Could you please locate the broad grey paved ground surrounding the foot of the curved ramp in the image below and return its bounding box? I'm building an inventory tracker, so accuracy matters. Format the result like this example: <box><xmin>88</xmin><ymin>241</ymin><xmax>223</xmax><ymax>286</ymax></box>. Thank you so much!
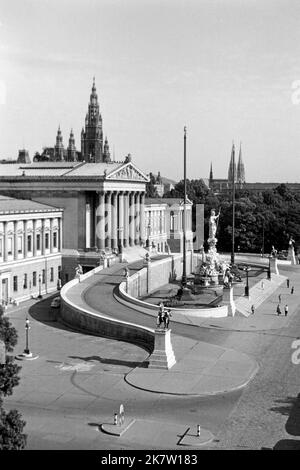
<box><xmin>5</xmin><ymin>258</ymin><xmax>300</xmax><ymax>450</ymax></box>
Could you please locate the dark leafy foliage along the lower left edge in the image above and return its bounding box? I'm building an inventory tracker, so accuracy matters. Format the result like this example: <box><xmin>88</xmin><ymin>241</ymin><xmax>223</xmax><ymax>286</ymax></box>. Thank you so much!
<box><xmin>0</xmin><ymin>306</ymin><xmax>27</xmax><ymax>450</ymax></box>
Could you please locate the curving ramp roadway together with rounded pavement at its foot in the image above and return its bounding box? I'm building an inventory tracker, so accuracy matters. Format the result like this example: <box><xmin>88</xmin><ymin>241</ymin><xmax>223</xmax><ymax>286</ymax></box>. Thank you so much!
<box><xmin>67</xmin><ymin>265</ymin><xmax>258</xmax><ymax>396</ymax></box>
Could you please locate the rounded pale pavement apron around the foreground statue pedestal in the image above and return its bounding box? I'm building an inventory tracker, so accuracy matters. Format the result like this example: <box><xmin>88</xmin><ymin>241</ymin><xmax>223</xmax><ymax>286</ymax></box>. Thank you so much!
<box><xmin>125</xmin><ymin>335</ymin><xmax>258</xmax><ymax>396</ymax></box>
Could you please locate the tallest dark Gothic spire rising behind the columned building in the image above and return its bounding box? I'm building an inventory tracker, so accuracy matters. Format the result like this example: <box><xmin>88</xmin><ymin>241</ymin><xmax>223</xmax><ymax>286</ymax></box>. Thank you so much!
<box><xmin>81</xmin><ymin>78</ymin><xmax>110</xmax><ymax>163</ymax></box>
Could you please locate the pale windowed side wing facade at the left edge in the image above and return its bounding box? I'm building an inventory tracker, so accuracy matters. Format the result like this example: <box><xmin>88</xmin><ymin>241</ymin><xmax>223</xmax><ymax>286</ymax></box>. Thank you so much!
<box><xmin>0</xmin><ymin>196</ymin><xmax>62</xmax><ymax>306</ymax></box>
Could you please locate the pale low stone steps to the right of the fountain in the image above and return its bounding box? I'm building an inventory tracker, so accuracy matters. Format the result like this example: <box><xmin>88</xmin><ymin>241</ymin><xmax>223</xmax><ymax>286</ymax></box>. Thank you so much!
<box><xmin>235</xmin><ymin>274</ymin><xmax>286</xmax><ymax>317</ymax></box>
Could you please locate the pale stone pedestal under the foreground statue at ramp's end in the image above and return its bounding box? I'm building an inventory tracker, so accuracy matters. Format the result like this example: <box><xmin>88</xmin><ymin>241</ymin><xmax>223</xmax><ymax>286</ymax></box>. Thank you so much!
<box><xmin>149</xmin><ymin>328</ymin><xmax>176</xmax><ymax>369</ymax></box>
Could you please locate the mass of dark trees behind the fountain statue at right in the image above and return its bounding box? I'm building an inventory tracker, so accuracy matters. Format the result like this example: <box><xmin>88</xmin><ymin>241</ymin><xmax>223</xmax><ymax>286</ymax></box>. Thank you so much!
<box><xmin>165</xmin><ymin>180</ymin><xmax>300</xmax><ymax>253</ymax></box>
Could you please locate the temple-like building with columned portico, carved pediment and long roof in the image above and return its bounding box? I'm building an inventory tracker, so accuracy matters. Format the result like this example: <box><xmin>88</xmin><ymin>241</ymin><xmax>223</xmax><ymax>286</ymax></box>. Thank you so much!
<box><xmin>0</xmin><ymin>160</ymin><xmax>148</xmax><ymax>280</ymax></box>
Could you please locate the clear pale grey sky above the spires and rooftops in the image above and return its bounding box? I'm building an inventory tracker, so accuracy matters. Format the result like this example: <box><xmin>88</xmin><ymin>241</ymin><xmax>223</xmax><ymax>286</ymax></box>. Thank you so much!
<box><xmin>0</xmin><ymin>0</ymin><xmax>300</xmax><ymax>182</ymax></box>
